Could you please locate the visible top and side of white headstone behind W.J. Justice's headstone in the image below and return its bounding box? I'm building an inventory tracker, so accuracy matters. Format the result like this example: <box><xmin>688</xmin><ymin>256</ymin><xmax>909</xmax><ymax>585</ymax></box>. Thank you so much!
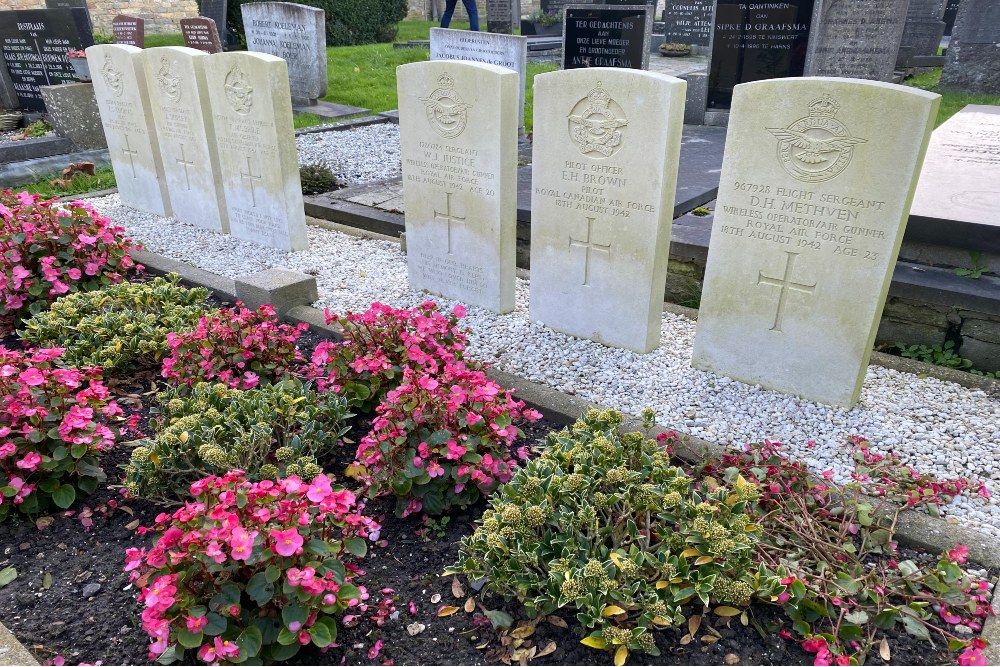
<box><xmin>431</xmin><ymin>28</ymin><xmax>528</xmax><ymax>127</ymax></box>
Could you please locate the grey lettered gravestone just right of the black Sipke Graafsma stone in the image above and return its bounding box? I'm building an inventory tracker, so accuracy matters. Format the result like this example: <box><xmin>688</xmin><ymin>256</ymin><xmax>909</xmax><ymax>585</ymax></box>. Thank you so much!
<box><xmin>805</xmin><ymin>0</ymin><xmax>910</xmax><ymax>81</ymax></box>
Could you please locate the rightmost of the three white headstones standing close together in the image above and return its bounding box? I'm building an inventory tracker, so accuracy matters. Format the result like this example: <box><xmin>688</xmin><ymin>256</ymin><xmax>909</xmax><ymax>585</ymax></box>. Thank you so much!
<box><xmin>204</xmin><ymin>52</ymin><xmax>309</xmax><ymax>250</ymax></box>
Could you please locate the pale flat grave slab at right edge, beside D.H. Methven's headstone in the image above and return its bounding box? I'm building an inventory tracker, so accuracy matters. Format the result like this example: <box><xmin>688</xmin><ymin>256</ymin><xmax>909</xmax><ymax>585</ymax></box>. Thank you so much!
<box><xmin>910</xmin><ymin>104</ymin><xmax>1000</xmax><ymax>252</ymax></box>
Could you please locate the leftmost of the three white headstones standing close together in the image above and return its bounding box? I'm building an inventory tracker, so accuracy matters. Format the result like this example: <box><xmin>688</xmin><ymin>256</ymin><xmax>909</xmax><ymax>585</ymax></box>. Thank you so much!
<box><xmin>87</xmin><ymin>44</ymin><xmax>171</xmax><ymax>215</ymax></box>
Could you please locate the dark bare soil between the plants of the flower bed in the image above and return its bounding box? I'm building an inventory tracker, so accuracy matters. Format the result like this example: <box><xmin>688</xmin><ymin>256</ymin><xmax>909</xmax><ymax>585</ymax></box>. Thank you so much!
<box><xmin>0</xmin><ymin>316</ymin><xmax>988</xmax><ymax>665</ymax></box>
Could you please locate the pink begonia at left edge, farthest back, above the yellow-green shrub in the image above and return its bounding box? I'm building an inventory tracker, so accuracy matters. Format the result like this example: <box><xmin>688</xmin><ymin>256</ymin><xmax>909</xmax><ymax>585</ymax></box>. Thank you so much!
<box><xmin>0</xmin><ymin>190</ymin><xmax>141</xmax><ymax>334</ymax></box>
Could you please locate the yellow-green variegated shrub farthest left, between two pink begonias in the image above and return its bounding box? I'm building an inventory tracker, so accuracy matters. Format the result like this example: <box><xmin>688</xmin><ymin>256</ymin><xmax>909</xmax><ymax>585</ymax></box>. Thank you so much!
<box><xmin>19</xmin><ymin>274</ymin><xmax>210</xmax><ymax>377</ymax></box>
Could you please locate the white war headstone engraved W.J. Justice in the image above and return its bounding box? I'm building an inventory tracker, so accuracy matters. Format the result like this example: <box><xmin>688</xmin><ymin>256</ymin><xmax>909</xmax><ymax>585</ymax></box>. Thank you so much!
<box><xmin>396</xmin><ymin>60</ymin><xmax>518</xmax><ymax>313</ymax></box>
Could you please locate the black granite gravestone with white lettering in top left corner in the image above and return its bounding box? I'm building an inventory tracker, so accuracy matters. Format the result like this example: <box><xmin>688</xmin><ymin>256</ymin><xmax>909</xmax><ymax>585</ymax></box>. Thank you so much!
<box><xmin>0</xmin><ymin>9</ymin><xmax>94</xmax><ymax>111</ymax></box>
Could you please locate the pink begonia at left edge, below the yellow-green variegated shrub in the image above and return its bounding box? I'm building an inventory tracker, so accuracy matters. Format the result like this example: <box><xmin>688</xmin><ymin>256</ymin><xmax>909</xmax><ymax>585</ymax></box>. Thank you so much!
<box><xmin>0</xmin><ymin>346</ymin><xmax>122</xmax><ymax>520</ymax></box>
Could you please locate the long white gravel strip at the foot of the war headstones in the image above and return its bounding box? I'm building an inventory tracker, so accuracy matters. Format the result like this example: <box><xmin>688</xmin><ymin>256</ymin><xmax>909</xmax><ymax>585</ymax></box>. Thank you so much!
<box><xmin>86</xmin><ymin>195</ymin><xmax>1000</xmax><ymax>536</ymax></box>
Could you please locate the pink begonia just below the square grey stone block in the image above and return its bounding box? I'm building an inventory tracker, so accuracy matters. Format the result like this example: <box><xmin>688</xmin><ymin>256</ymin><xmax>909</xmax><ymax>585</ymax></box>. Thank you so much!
<box><xmin>162</xmin><ymin>303</ymin><xmax>309</xmax><ymax>389</ymax></box>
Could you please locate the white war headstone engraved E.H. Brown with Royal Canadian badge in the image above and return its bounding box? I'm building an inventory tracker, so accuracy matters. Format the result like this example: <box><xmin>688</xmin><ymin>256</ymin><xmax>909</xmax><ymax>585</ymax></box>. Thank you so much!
<box><xmin>531</xmin><ymin>67</ymin><xmax>686</xmax><ymax>353</ymax></box>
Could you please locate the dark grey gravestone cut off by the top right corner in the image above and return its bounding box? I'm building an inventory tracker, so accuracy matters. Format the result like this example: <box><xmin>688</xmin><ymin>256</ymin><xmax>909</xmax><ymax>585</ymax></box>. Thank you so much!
<box><xmin>940</xmin><ymin>0</ymin><xmax>1000</xmax><ymax>95</ymax></box>
